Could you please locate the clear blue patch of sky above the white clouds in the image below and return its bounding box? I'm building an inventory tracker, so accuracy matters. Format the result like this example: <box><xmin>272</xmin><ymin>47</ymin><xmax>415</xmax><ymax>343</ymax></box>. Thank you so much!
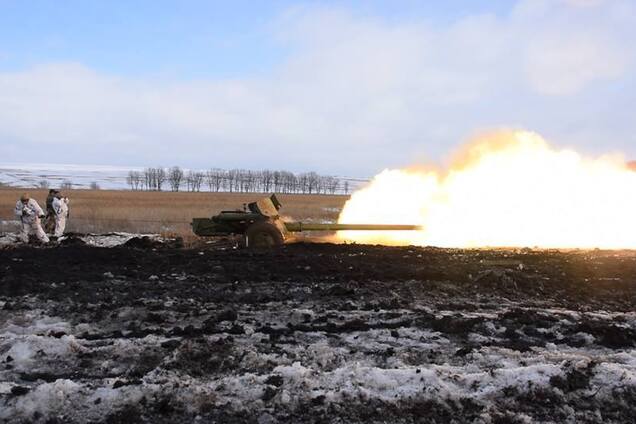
<box><xmin>0</xmin><ymin>0</ymin><xmax>511</xmax><ymax>79</ymax></box>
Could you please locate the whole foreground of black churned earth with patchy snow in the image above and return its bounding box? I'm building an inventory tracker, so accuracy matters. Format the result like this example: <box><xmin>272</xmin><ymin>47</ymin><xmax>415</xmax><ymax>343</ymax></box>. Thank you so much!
<box><xmin>0</xmin><ymin>239</ymin><xmax>636</xmax><ymax>424</ymax></box>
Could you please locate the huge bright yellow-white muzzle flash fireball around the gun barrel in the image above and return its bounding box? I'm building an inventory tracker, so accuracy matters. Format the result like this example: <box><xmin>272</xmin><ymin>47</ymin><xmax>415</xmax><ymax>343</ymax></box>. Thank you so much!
<box><xmin>338</xmin><ymin>131</ymin><xmax>636</xmax><ymax>248</ymax></box>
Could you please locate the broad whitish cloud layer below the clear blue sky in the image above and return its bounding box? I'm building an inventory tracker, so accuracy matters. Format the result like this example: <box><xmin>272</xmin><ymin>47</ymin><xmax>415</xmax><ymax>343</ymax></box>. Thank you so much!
<box><xmin>0</xmin><ymin>0</ymin><xmax>636</xmax><ymax>175</ymax></box>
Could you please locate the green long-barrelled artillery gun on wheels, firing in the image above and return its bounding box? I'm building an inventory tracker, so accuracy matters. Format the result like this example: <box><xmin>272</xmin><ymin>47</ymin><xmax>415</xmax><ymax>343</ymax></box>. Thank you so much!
<box><xmin>191</xmin><ymin>194</ymin><xmax>420</xmax><ymax>247</ymax></box>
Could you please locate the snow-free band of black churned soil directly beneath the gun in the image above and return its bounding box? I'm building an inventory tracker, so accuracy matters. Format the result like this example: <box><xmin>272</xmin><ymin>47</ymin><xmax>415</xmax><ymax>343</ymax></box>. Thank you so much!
<box><xmin>0</xmin><ymin>239</ymin><xmax>636</xmax><ymax>311</ymax></box>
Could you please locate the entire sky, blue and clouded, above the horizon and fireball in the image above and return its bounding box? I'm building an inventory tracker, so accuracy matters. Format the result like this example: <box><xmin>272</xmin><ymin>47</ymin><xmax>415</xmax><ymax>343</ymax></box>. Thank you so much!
<box><xmin>0</xmin><ymin>0</ymin><xmax>636</xmax><ymax>176</ymax></box>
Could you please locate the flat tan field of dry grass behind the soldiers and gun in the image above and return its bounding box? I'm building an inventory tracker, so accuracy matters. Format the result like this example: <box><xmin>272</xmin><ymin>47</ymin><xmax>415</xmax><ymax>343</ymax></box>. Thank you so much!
<box><xmin>0</xmin><ymin>188</ymin><xmax>349</xmax><ymax>235</ymax></box>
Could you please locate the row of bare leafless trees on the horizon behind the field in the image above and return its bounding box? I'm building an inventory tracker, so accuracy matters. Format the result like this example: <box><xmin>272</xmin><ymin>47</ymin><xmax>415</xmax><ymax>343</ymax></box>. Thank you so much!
<box><xmin>126</xmin><ymin>166</ymin><xmax>349</xmax><ymax>194</ymax></box>
